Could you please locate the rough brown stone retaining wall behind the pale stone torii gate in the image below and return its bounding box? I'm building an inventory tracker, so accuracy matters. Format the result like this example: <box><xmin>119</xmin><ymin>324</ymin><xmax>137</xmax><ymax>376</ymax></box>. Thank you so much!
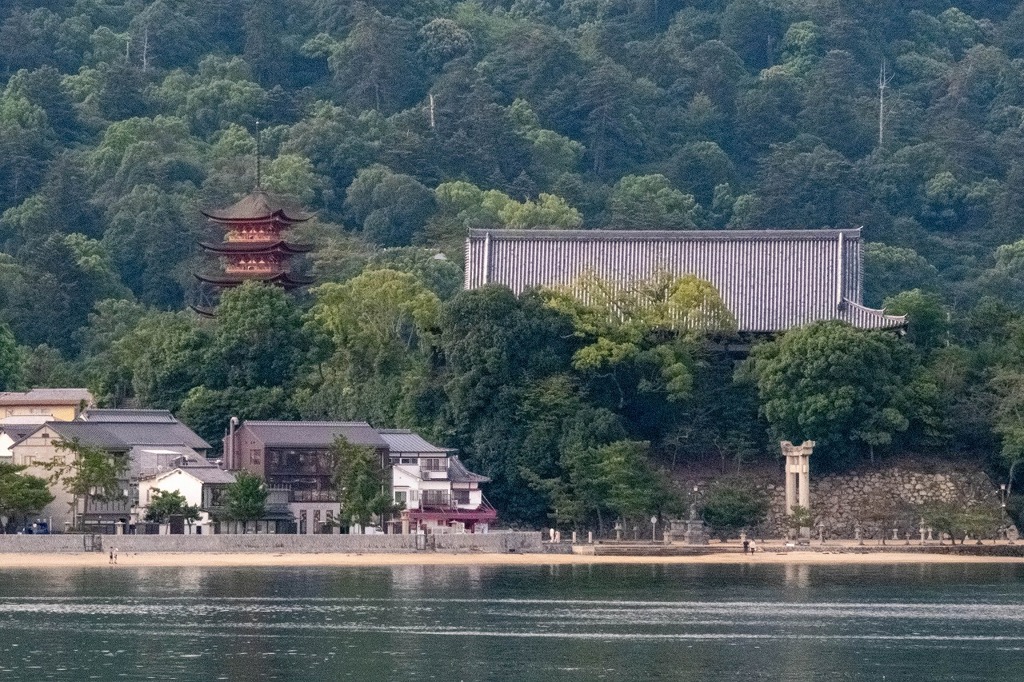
<box><xmin>765</xmin><ymin>467</ymin><xmax>998</xmax><ymax>540</ymax></box>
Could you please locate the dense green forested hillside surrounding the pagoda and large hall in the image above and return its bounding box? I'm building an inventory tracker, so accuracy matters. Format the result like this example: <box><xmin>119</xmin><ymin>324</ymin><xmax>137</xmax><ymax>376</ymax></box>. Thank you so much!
<box><xmin>0</xmin><ymin>0</ymin><xmax>1024</xmax><ymax>522</ymax></box>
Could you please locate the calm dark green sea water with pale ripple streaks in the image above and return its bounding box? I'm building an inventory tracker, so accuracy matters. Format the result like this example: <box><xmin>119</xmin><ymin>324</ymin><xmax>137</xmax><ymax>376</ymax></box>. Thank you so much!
<box><xmin>0</xmin><ymin>557</ymin><xmax>1024</xmax><ymax>682</ymax></box>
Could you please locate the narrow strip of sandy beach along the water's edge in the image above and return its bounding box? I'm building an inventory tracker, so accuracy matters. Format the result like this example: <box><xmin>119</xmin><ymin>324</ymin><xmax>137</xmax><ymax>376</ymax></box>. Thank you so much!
<box><xmin>0</xmin><ymin>549</ymin><xmax>1024</xmax><ymax>570</ymax></box>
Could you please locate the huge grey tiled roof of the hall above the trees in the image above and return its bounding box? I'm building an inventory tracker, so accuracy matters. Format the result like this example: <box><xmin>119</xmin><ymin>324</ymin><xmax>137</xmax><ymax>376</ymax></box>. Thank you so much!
<box><xmin>465</xmin><ymin>228</ymin><xmax>905</xmax><ymax>332</ymax></box>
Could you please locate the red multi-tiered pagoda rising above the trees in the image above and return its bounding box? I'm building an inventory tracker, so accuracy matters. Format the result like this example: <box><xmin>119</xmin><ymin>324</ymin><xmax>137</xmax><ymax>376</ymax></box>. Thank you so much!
<box><xmin>196</xmin><ymin>186</ymin><xmax>312</xmax><ymax>289</ymax></box>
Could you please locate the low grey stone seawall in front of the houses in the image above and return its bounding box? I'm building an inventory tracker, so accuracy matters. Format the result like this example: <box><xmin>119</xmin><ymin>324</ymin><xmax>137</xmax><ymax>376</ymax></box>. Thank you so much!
<box><xmin>0</xmin><ymin>531</ymin><xmax>544</xmax><ymax>554</ymax></box>
